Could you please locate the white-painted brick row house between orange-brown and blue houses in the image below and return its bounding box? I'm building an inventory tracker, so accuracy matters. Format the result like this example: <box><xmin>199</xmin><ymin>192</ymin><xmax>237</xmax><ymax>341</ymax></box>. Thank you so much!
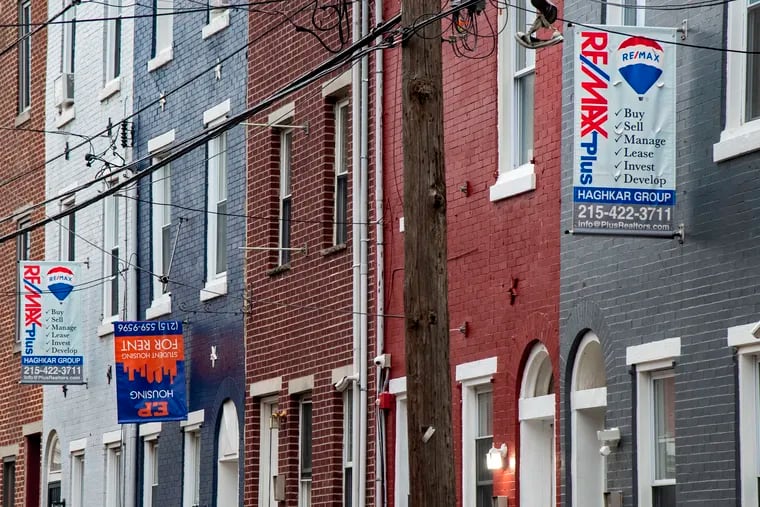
<box><xmin>42</xmin><ymin>2</ymin><xmax>137</xmax><ymax>506</ymax></box>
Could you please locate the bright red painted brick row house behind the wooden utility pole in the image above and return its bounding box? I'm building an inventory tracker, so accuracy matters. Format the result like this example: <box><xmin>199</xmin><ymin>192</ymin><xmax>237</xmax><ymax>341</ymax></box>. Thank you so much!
<box><xmin>383</xmin><ymin>2</ymin><xmax>562</xmax><ymax>507</ymax></box>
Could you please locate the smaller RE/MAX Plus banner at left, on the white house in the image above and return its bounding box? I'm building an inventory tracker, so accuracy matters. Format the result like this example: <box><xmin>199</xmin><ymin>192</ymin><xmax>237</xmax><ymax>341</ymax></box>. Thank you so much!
<box><xmin>19</xmin><ymin>261</ymin><xmax>84</xmax><ymax>384</ymax></box>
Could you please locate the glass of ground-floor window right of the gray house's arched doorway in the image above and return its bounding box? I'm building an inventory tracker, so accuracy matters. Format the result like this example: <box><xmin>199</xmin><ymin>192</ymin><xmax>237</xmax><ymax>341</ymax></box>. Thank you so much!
<box><xmin>652</xmin><ymin>377</ymin><xmax>676</xmax><ymax>480</ymax></box>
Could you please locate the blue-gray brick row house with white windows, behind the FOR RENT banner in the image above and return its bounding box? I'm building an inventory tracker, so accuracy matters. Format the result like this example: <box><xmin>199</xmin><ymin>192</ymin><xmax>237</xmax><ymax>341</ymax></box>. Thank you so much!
<box><xmin>134</xmin><ymin>0</ymin><xmax>248</xmax><ymax>507</ymax></box>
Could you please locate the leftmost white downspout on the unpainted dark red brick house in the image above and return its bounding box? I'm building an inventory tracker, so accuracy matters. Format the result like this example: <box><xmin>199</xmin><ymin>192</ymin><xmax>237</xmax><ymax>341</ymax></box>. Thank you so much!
<box><xmin>351</xmin><ymin>0</ymin><xmax>366</xmax><ymax>505</ymax></box>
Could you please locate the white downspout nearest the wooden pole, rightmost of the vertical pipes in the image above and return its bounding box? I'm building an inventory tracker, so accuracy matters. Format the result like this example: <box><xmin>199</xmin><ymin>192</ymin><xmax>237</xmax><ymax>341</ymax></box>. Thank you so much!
<box><xmin>375</xmin><ymin>0</ymin><xmax>387</xmax><ymax>507</ymax></box>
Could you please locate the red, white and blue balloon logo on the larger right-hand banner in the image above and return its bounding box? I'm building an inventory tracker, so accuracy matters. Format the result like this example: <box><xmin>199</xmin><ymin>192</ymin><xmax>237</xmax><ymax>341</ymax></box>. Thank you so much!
<box><xmin>618</xmin><ymin>37</ymin><xmax>665</xmax><ymax>100</ymax></box>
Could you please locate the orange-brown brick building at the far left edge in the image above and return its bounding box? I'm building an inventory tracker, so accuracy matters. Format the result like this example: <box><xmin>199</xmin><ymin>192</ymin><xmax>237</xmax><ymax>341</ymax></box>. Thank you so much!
<box><xmin>0</xmin><ymin>1</ymin><xmax>47</xmax><ymax>507</ymax></box>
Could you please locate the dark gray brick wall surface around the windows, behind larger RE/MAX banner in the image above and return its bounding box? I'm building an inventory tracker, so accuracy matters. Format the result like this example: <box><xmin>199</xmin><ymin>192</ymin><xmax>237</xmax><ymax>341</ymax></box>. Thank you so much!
<box><xmin>560</xmin><ymin>0</ymin><xmax>760</xmax><ymax>507</ymax></box>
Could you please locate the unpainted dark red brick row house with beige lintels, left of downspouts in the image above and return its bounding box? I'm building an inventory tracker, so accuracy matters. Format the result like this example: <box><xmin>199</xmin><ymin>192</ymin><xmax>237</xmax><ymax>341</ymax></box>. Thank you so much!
<box><xmin>244</xmin><ymin>1</ymin><xmax>380</xmax><ymax>507</ymax></box>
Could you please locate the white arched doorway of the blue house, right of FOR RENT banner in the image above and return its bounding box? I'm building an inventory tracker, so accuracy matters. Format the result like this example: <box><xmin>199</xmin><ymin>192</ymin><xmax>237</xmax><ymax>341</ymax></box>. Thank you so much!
<box><xmin>216</xmin><ymin>400</ymin><xmax>240</xmax><ymax>507</ymax></box>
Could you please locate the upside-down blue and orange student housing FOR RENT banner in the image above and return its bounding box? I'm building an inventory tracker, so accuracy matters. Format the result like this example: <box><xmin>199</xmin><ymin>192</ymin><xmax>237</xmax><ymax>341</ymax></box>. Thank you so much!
<box><xmin>114</xmin><ymin>321</ymin><xmax>187</xmax><ymax>424</ymax></box>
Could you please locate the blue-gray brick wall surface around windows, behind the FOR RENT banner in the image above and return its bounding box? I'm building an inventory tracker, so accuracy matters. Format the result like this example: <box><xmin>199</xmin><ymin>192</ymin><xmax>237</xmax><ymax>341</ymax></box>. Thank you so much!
<box><xmin>134</xmin><ymin>1</ymin><xmax>248</xmax><ymax>507</ymax></box>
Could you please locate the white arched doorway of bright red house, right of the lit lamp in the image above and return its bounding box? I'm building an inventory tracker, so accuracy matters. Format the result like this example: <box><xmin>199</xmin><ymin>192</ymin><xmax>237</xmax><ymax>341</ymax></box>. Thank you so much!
<box><xmin>519</xmin><ymin>343</ymin><xmax>556</xmax><ymax>507</ymax></box>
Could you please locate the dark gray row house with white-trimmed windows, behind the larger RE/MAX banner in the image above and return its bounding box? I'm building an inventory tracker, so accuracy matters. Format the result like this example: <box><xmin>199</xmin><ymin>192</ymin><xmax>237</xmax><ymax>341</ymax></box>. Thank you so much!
<box><xmin>559</xmin><ymin>0</ymin><xmax>760</xmax><ymax>507</ymax></box>
